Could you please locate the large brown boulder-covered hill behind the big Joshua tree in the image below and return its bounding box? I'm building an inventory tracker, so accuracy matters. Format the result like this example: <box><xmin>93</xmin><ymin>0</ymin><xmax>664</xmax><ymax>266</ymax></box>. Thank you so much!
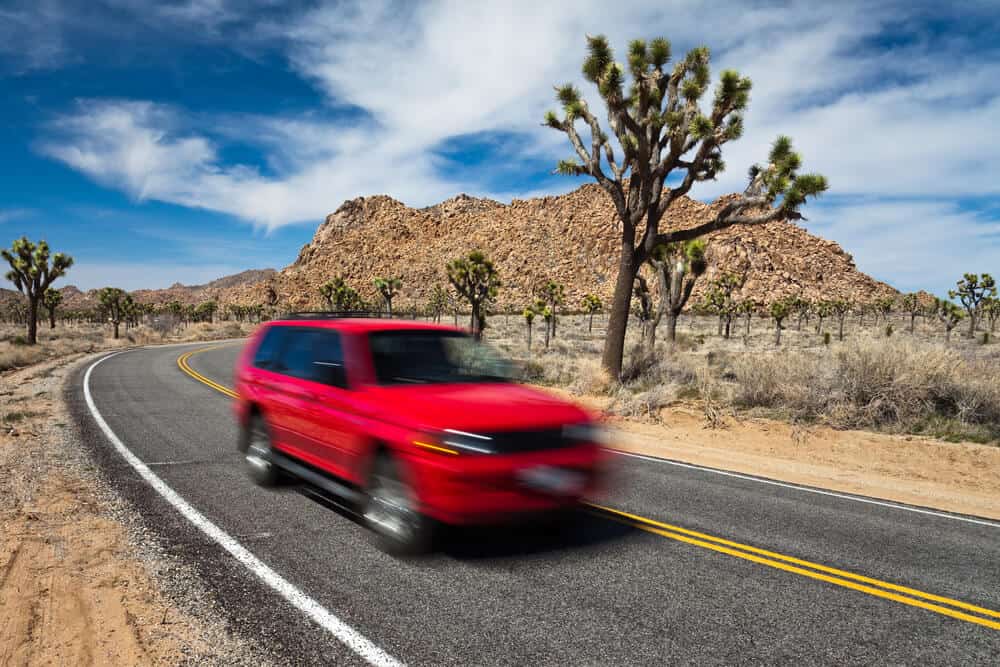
<box><xmin>222</xmin><ymin>184</ymin><xmax>896</xmax><ymax>309</ymax></box>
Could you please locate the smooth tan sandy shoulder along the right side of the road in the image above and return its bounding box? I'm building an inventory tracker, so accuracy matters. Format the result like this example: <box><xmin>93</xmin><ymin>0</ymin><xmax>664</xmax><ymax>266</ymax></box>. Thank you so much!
<box><xmin>560</xmin><ymin>396</ymin><xmax>1000</xmax><ymax>519</ymax></box>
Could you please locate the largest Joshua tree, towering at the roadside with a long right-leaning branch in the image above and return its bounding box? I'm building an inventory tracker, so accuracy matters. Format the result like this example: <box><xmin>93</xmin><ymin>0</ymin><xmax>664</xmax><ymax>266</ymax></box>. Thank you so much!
<box><xmin>545</xmin><ymin>36</ymin><xmax>827</xmax><ymax>378</ymax></box>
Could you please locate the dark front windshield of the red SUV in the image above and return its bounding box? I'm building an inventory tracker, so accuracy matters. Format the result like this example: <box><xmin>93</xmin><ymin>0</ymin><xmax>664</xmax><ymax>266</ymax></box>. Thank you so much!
<box><xmin>369</xmin><ymin>330</ymin><xmax>513</xmax><ymax>384</ymax></box>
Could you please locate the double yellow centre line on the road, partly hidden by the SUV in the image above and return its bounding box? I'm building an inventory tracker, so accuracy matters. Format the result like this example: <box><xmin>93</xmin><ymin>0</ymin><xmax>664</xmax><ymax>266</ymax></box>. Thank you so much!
<box><xmin>177</xmin><ymin>345</ymin><xmax>1000</xmax><ymax>630</ymax></box>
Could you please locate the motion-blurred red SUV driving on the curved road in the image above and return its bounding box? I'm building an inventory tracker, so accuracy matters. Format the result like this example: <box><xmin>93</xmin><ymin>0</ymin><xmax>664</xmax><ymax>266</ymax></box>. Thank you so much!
<box><xmin>235</xmin><ymin>315</ymin><xmax>606</xmax><ymax>552</ymax></box>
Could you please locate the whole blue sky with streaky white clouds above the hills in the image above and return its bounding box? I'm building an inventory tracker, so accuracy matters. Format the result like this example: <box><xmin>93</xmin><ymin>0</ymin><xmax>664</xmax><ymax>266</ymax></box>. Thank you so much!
<box><xmin>0</xmin><ymin>0</ymin><xmax>1000</xmax><ymax>293</ymax></box>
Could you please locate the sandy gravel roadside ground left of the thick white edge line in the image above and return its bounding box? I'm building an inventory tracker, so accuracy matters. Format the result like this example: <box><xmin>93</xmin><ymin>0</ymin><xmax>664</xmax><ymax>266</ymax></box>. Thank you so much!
<box><xmin>0</xmin><ymin>358</ymin><xmax>260</xmax><ymax>665</ymax></box>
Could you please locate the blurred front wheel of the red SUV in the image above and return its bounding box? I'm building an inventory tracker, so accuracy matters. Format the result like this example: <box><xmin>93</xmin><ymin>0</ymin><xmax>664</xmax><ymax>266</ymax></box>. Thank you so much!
<box><xmin>362</xmin><ymin>454</ymin><xmax>433</xmax><ymax>556</ymax></box>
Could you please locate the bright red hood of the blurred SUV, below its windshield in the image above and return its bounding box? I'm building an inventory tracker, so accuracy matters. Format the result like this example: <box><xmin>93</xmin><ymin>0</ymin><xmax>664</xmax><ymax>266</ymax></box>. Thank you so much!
<box><xmin>366</xmin><ymin>383</ymin><xmax>590</xmax><ymax>433</ymax></box>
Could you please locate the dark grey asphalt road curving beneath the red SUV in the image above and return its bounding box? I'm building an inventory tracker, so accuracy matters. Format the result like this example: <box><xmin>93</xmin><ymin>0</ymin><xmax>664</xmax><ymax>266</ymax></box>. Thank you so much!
<box><xmin>69</xmin><ymin>345</ymin><xmax>1000</xmax><ymax>665</ymax></box>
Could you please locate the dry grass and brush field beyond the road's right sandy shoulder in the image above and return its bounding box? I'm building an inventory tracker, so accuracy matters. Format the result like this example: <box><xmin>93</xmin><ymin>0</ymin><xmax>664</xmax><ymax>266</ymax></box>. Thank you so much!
<box><xmin>487</xmin><ymin>316</ymin><xmax>1000</xmax><ymax>442</ymax></box>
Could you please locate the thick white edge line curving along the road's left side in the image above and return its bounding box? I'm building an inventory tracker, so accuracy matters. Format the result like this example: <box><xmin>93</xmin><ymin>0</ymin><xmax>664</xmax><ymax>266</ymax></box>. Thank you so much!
<box><xmin>83</xmin><ymin>352</ymin><xmax>403</xmax><ymax>667</ymax></box>
